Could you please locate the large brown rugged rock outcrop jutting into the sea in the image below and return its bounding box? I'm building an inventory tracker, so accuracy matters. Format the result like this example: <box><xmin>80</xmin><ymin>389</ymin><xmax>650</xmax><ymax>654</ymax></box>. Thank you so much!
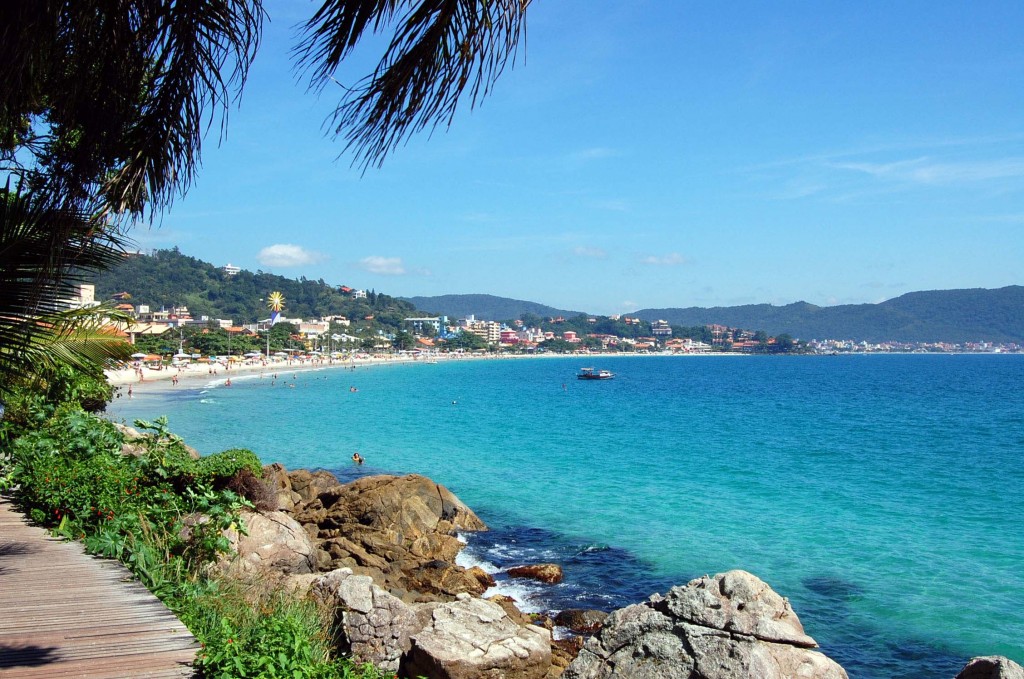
<box><xmin>288</xmin><ymin>468</ymin><xmax>487</xmax><ymax>602</ymax></box>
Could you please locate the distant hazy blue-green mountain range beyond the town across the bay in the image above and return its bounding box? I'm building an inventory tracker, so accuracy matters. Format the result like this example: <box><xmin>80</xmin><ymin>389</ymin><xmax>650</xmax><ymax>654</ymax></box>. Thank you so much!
<box><xmin>407</xmin><ymin>286</ymin><xmax>1024</xmax><ymax>343</ymax></box>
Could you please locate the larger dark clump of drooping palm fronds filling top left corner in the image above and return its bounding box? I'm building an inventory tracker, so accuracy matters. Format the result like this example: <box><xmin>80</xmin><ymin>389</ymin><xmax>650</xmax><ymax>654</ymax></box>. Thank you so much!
<box><xmin>0</xmin><ymin>0</ymin><xmax>263</xmax><ymax>216</ymax></box>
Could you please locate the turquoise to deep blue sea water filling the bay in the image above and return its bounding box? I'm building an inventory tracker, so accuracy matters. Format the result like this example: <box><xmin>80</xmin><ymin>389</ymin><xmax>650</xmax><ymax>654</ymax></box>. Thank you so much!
<box><xmin>112</xmin><ymin>355</ymin><xmax>1024</xmax><ymax>679</ymax></box>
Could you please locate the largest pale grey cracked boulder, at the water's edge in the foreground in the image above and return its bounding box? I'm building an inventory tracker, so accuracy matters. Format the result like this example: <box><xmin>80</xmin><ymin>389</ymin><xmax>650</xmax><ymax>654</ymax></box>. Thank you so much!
<box><xmin>563</xmin><ymin>570</ymin><xmax>847</xmax><ymax>679</ymax></box>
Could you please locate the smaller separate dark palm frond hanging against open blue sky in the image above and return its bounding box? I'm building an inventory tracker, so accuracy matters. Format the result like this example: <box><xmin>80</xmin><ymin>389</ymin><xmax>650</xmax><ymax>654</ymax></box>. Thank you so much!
<box><xmin>297</xmin><ymin>0</ymin><xmax>529</xmax><ymax>168</ymax></box>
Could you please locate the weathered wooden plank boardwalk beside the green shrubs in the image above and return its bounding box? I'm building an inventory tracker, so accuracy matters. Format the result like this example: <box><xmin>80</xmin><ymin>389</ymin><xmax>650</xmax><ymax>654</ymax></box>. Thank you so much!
<box><xmin>0</xmin><ymin>500</ymin><xmax>199</xmax><ymax>679</ymax></box>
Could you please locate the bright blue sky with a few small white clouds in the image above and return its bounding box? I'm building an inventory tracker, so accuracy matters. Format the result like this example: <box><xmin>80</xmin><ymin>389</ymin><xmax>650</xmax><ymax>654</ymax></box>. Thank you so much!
<box><xmin>132</xmin><ymin>0</ymin><xmax>1024</xmax><ymax>313</ymax></box>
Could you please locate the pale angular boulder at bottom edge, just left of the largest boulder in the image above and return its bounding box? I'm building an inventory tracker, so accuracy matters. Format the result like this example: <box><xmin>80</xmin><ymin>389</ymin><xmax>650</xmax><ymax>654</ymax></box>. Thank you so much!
<box><xmin>400</xmin><ymin>594</ymin><xmax>551</xmax><ymax>679</ymax></box>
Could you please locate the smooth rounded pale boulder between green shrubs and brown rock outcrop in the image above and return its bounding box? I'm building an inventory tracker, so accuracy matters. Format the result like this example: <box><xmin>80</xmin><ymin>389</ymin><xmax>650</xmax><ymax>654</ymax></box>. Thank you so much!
<box><xmin>228</xmin><ymin>511</ymin><xmax>316</xmax><ymax>575</ymax></box>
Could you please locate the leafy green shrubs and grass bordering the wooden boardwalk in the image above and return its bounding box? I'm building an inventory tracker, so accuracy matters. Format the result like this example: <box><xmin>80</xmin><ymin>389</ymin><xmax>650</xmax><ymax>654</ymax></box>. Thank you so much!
<box><xmin>0</xmin><ymin>377</ymin><xmax>395</xmax><ymax>679</ymax></box>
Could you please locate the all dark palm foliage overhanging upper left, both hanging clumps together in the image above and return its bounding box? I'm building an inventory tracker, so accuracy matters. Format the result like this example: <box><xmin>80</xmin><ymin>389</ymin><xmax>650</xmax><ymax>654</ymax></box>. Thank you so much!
<box><xmin>6</xmin><ymin>0</ymin><xmax>529</xmax><ymax>393</ymax></box>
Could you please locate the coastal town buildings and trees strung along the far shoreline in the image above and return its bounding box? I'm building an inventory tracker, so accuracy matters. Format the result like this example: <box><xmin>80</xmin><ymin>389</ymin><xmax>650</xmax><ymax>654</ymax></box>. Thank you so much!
<box><xmin>68</xmin><ymin>278</ymin><xmax>1024</xmax><ymax>359</ymax></box>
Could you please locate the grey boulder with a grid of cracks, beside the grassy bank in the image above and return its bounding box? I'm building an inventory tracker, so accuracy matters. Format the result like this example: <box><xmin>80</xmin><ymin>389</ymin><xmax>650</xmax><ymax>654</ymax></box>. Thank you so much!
<box><xmin>309</xmin><ymin>568</ymin><xmax>419</xmax><ymax>672</ymax></box>
